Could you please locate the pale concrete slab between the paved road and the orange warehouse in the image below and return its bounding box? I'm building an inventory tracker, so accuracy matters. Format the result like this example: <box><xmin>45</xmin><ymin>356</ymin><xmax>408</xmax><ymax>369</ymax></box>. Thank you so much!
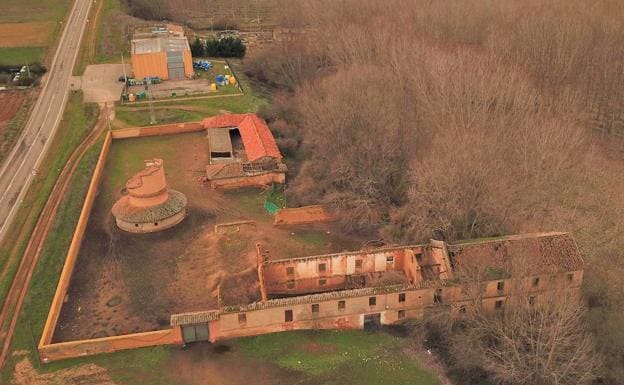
<box><xmin>81</xmin><ymin>64</ymin><xmax>132</xmax><ymax>103</ymax></box>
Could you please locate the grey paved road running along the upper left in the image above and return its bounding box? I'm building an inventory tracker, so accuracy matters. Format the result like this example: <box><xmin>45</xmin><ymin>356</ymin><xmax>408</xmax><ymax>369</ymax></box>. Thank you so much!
<box><xmin>0</xmin><ymin>0</ymin><xmax>92</xmax><ymax>240</ymax></box>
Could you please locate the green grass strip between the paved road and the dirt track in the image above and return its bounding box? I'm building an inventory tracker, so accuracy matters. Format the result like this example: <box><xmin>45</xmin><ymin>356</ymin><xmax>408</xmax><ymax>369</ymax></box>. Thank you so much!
<box><xmin>0</xmin><ymin>93</ymin><xmax>97</xmax><ymax>310</ymax></box>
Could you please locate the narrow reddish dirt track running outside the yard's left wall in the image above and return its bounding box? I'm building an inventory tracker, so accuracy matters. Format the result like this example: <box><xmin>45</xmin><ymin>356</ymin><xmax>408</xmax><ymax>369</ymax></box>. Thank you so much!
<box><xmin>0</xmin><ymin>104</ymin><xmax>107</xmax><ymax>368</ymax></box>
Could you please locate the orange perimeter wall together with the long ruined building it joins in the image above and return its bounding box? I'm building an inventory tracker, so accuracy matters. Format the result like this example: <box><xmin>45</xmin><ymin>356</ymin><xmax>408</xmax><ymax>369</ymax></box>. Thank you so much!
<box><xmin>39</xmin><ymin>119</ymin><xmax>583</xmax><ymax>362</ymax></box>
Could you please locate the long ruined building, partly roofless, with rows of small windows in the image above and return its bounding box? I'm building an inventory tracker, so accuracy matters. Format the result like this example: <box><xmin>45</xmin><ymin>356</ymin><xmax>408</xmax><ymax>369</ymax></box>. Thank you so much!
<box><xmin>171</xmin><ymin>233</ymin><xmax>583</xmax><ymax>342</ymax></box>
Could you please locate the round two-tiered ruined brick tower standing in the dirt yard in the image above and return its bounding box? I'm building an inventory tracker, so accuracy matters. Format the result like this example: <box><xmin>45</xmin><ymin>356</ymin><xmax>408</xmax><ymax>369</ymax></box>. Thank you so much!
<box><xmin>112</xmin><ymin>159</ymin><xmax>186</xmax><ymax>233</ymax></box>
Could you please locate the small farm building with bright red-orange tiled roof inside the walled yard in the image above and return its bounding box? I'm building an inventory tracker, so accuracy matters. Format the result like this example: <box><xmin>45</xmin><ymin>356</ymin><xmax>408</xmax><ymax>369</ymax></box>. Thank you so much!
<box><xmin>203</xmin><ymin>114</ymin><xmax>287</xmax><ymax>188</ymax></box>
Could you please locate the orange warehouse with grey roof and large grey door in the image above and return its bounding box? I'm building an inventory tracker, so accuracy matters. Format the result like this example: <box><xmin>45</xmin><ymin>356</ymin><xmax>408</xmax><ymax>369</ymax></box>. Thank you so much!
<box><xmin>131</xmin><ymin>25</ymin><xmax>193</xmax><ymax>80</ymax></box>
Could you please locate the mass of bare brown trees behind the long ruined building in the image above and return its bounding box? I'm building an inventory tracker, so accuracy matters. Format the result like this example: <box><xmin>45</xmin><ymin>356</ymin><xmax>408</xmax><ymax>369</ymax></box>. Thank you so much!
<box><xmin>240</xmin><ymin>0</ymin><xmax>624</xmax><ymax>384</ymax></box>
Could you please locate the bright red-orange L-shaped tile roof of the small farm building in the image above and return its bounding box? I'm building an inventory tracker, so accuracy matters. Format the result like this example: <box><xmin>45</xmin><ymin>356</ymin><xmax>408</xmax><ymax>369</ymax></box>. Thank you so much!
<box><xmin>203</xmin><ymin>114</ymin><xmax>282</xmax><ymax>161</ymax></box>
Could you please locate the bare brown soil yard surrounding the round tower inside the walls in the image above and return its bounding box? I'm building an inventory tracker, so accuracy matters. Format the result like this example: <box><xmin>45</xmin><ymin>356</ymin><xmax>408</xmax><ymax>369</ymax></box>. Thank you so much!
<box><xmin>53</xmin><ymin>132</ymin><xmax>362</xmax><ymax>342</ymax></box>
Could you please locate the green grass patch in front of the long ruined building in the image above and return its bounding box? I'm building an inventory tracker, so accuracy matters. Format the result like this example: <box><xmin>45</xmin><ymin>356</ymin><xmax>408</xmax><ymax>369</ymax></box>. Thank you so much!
<box><xmin>234</xmin><ymin>330</ymin><xmax>439</xmax><ymax>385</ymax></box>
